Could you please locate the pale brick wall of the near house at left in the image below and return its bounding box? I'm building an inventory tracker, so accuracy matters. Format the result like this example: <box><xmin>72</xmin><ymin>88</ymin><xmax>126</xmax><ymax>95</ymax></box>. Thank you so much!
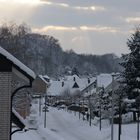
<box><xmin>0</xmin><ymin>72</ymin><xmax>12</xmax><ymax>140</ymax></box>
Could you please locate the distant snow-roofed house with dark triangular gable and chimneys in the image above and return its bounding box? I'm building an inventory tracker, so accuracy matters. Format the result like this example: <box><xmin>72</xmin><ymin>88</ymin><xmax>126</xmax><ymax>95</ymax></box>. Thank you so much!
<box><xmin>48</xmin><ymin>75</ymin><xmax>96</xmax><ymax>96</ymax></box>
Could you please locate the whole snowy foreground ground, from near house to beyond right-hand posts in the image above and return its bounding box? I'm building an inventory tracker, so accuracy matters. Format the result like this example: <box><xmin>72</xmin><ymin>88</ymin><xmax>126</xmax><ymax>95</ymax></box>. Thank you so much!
<box><xmin>12</xmin><ymin>108</ymin><xmax>137</xmax><ymax>140</ymax></box>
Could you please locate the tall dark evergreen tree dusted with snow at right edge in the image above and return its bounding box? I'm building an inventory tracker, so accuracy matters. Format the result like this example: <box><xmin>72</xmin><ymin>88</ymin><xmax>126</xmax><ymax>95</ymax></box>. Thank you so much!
<box><xmin>121</xmin><ymin>28</ymin><xmax>140</xmax><ymax>99</ymax></box>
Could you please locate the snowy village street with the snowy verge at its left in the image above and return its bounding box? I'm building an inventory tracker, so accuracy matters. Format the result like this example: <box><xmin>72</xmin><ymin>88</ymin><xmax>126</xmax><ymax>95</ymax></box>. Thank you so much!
<box><xmin>13</xmin><ymin>108</ymin><xmax>108</xmax><ymax>140</ymax></box>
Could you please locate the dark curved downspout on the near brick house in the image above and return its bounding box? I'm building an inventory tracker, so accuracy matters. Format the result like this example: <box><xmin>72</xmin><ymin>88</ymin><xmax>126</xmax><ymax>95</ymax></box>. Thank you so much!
<box><xmin>10</xmin><ymin>79</ymin><xmax>33</xmax><ymax>140</ymax></box>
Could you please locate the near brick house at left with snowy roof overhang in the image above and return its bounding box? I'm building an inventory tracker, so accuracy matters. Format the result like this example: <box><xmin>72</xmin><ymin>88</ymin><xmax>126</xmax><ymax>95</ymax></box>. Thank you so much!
<box><xmin>0</xmin><ymin>47</ymin><xmax>36</xmax><ymax>140</ymax></box>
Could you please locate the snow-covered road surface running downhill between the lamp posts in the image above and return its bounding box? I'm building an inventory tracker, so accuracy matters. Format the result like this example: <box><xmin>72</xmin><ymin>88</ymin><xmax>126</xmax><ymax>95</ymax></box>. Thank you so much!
<box><xmin>37</xmin><ymin>109</ymin><xmax>109</xmax><ymax>140</ymax></box>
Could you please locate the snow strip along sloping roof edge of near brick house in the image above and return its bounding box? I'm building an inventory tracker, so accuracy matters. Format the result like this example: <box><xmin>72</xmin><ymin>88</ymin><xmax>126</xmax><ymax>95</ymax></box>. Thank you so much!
<box><xmin>0</xmin><ymin>47</ymin><xmax>36</xmax><ymax>79</ymax></box>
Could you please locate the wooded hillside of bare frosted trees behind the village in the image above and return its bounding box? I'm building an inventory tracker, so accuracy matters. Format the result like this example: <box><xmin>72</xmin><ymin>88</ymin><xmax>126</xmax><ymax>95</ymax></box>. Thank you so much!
<box><xmin>0</xmin><ymin>23</ymin><xmax>120</xmax><ymax>77</ymax></box>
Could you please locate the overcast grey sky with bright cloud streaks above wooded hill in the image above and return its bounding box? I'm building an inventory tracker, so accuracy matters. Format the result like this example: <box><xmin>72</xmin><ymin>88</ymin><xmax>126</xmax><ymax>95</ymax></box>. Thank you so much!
<box><xmin>0</xmin><ymin>0</ymin><xmax>140</xmax><ymax>56</ymax></box>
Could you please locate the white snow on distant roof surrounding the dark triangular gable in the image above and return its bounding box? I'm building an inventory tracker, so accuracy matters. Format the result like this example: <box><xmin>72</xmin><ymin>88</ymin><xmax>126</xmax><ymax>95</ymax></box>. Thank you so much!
<box><xmin>48</xmin><ymin>75</ymin><xmax>95</xmax><ymax>96</ymax></box>
